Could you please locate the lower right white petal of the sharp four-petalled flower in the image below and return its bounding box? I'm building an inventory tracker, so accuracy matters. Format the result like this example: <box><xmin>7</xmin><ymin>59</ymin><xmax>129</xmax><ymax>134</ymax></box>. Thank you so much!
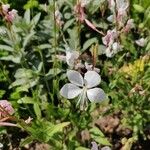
<box><xmin>87</xmin><ymin>88</ymin><xmax>106</xmax><ymax>103</ymax></box>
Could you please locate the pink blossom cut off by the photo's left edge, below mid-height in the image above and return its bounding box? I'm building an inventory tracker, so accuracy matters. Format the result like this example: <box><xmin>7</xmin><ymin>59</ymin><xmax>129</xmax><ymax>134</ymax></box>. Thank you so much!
<box><xmin>0</xmin><ymin>100</ymin><xmax>14</xmax><ymax>118</ymax></box>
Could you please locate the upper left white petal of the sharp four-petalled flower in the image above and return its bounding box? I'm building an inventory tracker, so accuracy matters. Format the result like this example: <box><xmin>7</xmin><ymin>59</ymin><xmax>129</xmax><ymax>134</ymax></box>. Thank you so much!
<box><xmin>67</xmin><ymin>70</ymin><xmax>84</xmax><ymax>86</ymax></box>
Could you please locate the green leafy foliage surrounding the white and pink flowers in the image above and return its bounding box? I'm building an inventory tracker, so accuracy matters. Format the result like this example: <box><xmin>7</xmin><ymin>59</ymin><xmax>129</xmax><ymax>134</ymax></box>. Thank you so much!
<box><xmin>0</xmin><ymin>0</ymin><xmax>150</xmax><ymax>150</ymax></box>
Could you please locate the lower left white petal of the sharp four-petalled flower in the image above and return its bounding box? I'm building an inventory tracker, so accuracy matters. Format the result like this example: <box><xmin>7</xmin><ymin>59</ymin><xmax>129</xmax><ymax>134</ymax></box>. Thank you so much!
<box><xmin>60</xmin><ymin>83</ymin><xmax>82</xmax><ymax>99</ymax></box>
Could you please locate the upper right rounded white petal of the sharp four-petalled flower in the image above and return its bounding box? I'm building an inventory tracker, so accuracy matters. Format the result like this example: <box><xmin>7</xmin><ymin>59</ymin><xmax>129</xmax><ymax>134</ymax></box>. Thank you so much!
<box><xmin>84</xmin><ymin>71</ymin><xmax>101</xmax><ymax>88</ymax></box>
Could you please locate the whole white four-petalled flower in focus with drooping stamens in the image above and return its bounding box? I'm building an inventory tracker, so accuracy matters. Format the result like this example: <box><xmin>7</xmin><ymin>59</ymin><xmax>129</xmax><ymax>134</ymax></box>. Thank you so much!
<box><xmin>60</xmin><ymin>70</ymin><xmax>106</xmax><ymax>109</ymax></box>
